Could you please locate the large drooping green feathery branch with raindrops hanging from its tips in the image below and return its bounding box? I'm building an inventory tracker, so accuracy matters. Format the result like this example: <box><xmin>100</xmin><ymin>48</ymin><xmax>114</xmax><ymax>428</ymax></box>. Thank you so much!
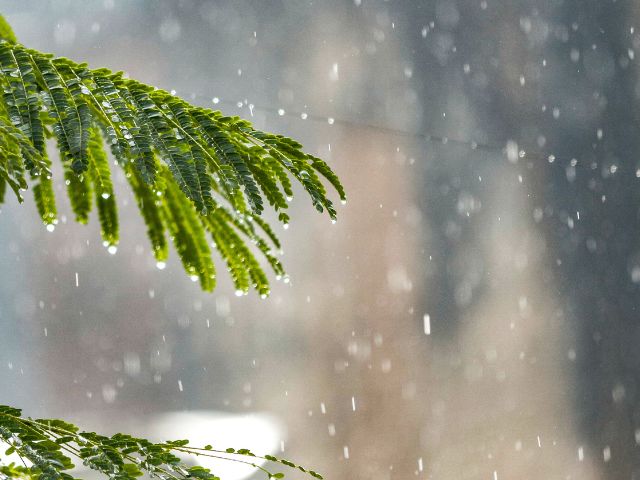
<box><xmin>0</xmin><ymin>40</ymin><xmax>345</xmax><ymax>295</ymax></box>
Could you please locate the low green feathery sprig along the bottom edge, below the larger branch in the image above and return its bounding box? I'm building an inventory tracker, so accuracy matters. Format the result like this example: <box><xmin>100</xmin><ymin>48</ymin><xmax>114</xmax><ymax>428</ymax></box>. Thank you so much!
<box><xmin>0</xmin><ymin>405</ymin><xmax>322</xmax><ymax>480</ymax></box>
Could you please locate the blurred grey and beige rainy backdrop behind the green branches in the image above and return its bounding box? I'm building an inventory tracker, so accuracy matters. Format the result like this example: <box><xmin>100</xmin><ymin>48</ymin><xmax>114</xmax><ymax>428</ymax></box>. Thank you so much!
<box><xmin>0</xmin><ymin>0</ymin><xmax>640</xmax><ymax>480</ymax></box>
